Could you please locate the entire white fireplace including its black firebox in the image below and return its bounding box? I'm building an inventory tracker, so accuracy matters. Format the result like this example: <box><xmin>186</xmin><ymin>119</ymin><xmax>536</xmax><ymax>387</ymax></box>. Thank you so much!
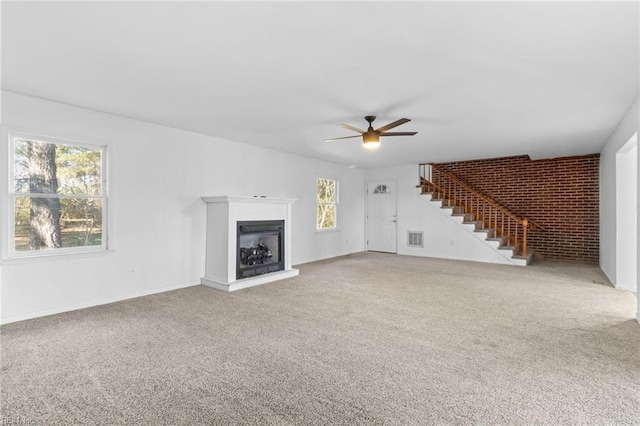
<box><xmin>201</xmin><ymin>195</ymin><xmax>298</xmax><ymax>291</ymax></box>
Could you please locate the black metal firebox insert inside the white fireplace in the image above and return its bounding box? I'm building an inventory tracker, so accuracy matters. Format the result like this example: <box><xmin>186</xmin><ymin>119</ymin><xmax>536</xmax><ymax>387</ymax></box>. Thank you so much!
<box><xmin>236</xmin><ymin>220</ymin><xmax>284</xmax><ymax>279</ymax></box>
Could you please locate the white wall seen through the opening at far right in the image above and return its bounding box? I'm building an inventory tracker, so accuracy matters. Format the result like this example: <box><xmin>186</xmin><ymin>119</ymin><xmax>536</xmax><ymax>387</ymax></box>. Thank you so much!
<box><xmin>615</xmin><ymin>138</ymin><xmax>638</xmax><ymax>291</ymax></box>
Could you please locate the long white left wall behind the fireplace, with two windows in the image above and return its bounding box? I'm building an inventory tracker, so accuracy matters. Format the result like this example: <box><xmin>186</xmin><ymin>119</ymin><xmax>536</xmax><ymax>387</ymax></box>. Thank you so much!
<box><xmin>0</xmin><ymin>92</ymin><xmax>364</xmax><ymax>323</ymax></box>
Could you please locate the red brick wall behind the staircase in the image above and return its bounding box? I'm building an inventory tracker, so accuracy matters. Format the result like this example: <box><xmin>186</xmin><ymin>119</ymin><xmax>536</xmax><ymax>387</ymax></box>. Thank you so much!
<box><xmin>440</xmin><ymin>154</ymin><xmax>600</xmax><ymax>264</ymax></box>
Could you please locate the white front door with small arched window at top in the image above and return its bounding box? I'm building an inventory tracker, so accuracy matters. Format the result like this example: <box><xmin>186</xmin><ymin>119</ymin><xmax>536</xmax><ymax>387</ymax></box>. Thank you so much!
<box><xmin>367</xmin><ymin>181</ymin><xmax>397</xmax><ymax>253</ymax></box>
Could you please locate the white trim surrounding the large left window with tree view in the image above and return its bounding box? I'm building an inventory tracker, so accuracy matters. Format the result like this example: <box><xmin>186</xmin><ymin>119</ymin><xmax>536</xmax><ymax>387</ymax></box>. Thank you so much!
<box><xmin>0</xmin><ymin>127</ymin><xmax>112</xmax><ymax>263</ymax></box>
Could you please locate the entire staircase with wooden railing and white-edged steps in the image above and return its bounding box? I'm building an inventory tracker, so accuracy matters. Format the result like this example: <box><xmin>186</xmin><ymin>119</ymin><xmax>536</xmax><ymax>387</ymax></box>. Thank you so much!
<box><xmin>417</xmin><ymin>164</ymin><xmax>542</xmax><ymax>266</ymax></box>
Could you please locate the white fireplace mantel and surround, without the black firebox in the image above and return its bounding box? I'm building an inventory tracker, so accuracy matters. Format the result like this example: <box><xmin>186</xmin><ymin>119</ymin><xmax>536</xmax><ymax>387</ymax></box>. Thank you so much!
<box><xmin>201</xmin><ymin>195</ymin><xmax>298</xmax><ymax>291</ymax></box>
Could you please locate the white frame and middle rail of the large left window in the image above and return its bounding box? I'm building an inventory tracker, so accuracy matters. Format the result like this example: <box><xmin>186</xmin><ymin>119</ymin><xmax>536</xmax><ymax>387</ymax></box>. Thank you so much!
<box><xmin>1</xmin><ymin>129</ymin><xmax>111</xmax><ymax>260</ymax></box>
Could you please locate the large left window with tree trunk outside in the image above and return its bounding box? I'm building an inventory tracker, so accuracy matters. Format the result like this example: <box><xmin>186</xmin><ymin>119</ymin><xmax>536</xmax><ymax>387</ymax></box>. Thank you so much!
<box><xmin>9</xmin><ymin>133</ymin><xmax>107</xmax><ymax>255</ymax></box>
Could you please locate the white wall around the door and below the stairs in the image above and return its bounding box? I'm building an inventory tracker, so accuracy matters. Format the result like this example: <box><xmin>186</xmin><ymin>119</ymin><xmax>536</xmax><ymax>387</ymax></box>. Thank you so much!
<box><xmin>365</xmin><ymin>164</ymin><xmax>510</xmax><ymax>264</ymax></box>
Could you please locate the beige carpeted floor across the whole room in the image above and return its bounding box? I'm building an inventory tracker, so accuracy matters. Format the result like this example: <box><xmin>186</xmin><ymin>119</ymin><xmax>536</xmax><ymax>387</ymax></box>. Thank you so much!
<box><xmin>0</xmin><ymin>253</ymin><xmax>640</xmax><ymax>425</ymax></box>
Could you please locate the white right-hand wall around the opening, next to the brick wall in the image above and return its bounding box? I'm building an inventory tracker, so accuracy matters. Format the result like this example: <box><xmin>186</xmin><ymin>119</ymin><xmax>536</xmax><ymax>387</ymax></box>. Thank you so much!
<box><xmin>600</xmin><ymin>98</ymin><xmax>640</xmax><ymax>285</ymax></box>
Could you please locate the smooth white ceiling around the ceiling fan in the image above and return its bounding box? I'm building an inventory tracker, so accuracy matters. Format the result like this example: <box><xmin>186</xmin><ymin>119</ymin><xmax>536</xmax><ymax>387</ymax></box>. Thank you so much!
<box><xmin>2</xmin><ymin>1</ymin><xmax>639</xmax><ymax>167</ymax></box>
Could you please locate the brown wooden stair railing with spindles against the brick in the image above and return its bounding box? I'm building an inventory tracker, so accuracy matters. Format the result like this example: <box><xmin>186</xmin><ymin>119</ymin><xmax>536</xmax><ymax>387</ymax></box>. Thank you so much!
<box><xmin>418</xmin><ymin>163</ymin><xmax>542</xmax><ymax>258</ymax></box>
